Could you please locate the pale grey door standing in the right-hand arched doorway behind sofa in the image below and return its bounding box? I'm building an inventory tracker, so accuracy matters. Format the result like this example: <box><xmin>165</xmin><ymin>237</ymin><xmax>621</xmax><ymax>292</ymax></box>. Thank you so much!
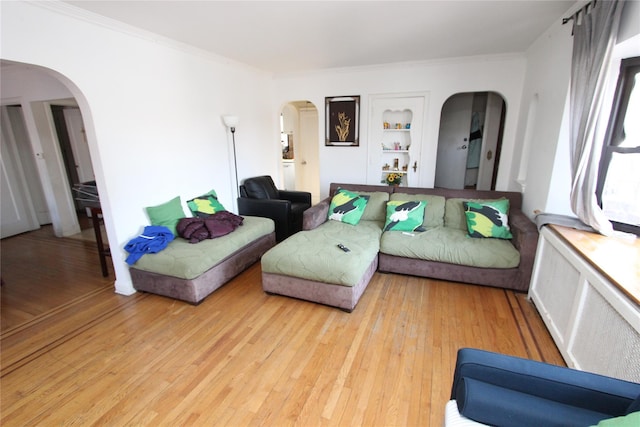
<box><xmin>435</xmin><ymin>93</ymin><xmax>473</xmax><ymax>189</ymax></box>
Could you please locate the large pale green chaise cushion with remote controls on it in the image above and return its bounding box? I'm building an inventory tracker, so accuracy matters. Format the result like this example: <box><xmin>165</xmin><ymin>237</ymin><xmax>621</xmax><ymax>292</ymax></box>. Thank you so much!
<box><xmin>262</xmin><ymin>220</ymin><xmax>382</xmax><ymax>286</ymax></box>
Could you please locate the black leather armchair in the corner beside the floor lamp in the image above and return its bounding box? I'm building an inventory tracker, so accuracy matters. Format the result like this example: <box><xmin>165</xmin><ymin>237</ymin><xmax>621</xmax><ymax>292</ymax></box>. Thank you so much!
<box><xmin>238</xmin><ymin>175</ymin><xmax>311</xmax><ymax>242</ymax></box>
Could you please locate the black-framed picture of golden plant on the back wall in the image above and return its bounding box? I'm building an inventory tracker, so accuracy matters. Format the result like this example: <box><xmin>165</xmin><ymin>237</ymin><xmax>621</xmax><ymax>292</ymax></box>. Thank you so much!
<box><xmin>324</xmin><ymin>96</ymin><xmax>360</xmax><ymax>147</ymax></box>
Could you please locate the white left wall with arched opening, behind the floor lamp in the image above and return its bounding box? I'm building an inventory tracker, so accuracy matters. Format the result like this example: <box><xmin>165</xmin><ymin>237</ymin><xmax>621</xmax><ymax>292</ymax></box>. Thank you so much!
<box><xmin>0</xmin><ymin>2</ymin><xmax>279</xmax><ymax>294</ymax></box>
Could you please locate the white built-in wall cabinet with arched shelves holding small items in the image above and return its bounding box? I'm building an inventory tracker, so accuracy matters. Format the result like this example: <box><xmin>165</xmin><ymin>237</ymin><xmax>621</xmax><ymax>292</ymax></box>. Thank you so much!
<box><xmin>368</xmin><ymin>95</ymin><xmax>426</xmax><ymax>187</ymax></box>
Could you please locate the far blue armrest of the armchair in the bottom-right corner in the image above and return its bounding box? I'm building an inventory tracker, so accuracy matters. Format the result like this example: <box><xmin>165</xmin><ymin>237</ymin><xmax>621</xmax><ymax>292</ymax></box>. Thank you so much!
<box><xmin>451</xmin><ymin>348</ymin><xmax>640</xmax><ymax>422</ymax></box>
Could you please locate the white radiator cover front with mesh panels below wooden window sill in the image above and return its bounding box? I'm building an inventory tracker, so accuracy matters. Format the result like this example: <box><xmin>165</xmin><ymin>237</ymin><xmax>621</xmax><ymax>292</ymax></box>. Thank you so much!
<box><xmin>529</xmin><ymin>227</ymin><xmax>640</xmax><ymax>382</ymax></box>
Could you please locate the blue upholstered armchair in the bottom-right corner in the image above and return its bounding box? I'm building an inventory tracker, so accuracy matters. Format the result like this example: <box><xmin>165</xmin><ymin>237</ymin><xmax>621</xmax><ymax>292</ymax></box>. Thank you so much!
<box><xmin>444</xmin><ymin>348</ymin><xmax>640</xmax><ymax>427</ymax></box>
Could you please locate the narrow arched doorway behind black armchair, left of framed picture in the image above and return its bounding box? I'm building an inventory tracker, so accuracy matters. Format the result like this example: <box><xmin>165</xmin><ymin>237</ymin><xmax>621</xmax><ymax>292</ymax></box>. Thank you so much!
<box><xmin>280</xmin><ymin>100</ymin><xmax>320</xmax><ymax>203</ymax></box>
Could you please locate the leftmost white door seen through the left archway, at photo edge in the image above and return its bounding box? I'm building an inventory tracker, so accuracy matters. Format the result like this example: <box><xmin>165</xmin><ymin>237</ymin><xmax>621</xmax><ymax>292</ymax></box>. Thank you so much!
<box><xmin>0</xmin><ymin>107</ymin><xmax>40</xmax><ymax>238</ymax></box>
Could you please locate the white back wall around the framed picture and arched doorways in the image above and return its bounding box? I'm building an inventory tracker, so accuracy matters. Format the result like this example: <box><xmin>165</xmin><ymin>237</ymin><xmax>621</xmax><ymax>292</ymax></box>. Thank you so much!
<box><xmin>274</xmin><ymin>55</ymin><xmax>525</xmax><ymax>197</ymax></box>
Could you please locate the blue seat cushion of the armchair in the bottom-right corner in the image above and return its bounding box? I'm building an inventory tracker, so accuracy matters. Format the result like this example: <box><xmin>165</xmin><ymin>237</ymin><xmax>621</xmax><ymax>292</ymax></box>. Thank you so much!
<box><xmin>456</xmin><ymin>378</ymin><xmax>610</xmax><ymax>427</ymax></box>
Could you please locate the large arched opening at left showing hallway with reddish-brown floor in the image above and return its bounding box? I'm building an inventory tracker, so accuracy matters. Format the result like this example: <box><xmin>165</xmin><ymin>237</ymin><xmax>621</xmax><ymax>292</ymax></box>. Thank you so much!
<box><xmin>0</xmin><ymin>61</ymin><xmax>114</xmax><ymax>332</ymax></box>
